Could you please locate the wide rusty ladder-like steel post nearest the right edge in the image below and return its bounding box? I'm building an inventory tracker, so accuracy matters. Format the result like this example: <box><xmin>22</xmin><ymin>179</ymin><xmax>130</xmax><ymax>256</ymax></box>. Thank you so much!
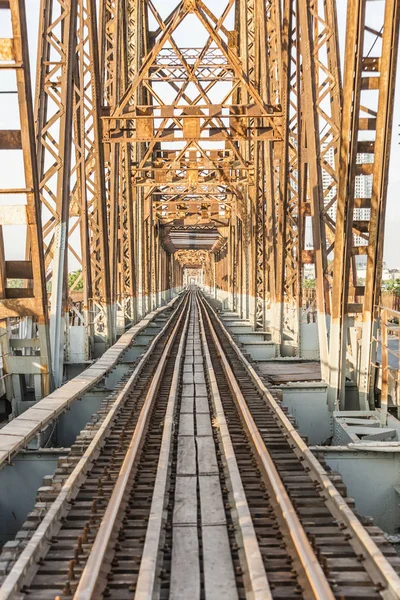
<box><xmin>329</xmin><ymin>0</ymin><xmax>400</xmax><ymax>409</ymax></box>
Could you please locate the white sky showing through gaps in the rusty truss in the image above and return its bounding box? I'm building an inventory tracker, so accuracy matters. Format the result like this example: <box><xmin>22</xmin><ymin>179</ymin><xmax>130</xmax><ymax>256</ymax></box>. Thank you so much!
<box><xmin>0</xmin><ymin>0</ymin><xmax>400</xmax><ymax>270</ymax></box>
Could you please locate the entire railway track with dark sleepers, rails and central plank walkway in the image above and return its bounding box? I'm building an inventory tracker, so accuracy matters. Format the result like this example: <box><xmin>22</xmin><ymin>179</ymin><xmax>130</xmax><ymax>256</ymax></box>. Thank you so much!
<box><xmin>0</xmin><ymin>292</ymin><xmax>400</xmax><ymax>600</ymax></box>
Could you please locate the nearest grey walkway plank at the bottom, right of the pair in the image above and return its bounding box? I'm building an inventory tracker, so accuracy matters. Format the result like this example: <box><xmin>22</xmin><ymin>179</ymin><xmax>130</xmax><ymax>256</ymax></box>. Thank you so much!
<box><xmin>203</xmin><ymin>525</ymin><xmax>238</xmax><ymax>600</ymax></box>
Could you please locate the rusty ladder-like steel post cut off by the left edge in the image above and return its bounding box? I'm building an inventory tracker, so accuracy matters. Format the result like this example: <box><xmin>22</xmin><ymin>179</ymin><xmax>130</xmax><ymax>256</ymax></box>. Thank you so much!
<box><xmin>0</xmin><ymin>0</ymin><xmax>52</xmax><ymax>400</ymax></box>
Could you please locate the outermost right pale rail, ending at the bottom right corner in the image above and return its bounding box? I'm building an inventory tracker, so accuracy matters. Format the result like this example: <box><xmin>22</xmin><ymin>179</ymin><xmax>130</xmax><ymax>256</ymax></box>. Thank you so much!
<box><xmin>201</xmin><ymin>297</ymin><xmax>400</xmax><ymax>600</ymax></box>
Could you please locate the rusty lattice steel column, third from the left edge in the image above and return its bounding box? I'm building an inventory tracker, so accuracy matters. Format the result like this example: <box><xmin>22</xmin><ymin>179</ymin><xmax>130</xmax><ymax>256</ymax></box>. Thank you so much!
<box><xmin>74</xmin><ymin>0</ymin><xmax>113</xmax><ymax>355</ymax></box>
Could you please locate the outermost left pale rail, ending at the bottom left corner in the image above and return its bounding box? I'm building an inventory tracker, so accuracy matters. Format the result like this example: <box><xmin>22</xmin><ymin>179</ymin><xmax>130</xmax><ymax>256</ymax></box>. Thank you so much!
<box><xmin>0</xmin><ymin>298</ymin><xmax>187</xmax><ymax>600</ymax></box>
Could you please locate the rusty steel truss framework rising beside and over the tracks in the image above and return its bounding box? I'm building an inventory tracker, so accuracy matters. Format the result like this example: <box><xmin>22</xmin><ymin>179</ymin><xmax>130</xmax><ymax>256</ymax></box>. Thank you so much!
<box><xmin>0</xmin><ymin>0</ymin><xmax>399</xmax><ymax>409</ymax></box>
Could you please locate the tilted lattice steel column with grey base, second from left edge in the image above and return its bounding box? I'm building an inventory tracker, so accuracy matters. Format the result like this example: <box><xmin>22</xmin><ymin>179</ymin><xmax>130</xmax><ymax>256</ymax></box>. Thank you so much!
<box><xmin>35</xmin><ymin>0</ymin><xmax>77</xmax><ymax>386</ymax></box>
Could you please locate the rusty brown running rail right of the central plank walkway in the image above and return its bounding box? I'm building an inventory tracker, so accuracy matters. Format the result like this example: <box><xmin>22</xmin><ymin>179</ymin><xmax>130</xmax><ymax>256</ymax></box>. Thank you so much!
<box><xmin>198</xmin><ymin>294</ymin><xmax>335</xmax><ymax>600</ymax></box>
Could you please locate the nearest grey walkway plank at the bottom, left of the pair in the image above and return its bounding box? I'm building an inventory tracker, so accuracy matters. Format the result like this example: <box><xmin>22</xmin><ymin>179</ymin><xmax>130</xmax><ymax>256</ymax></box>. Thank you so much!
<box><xmin>169</xmin><ymin>527</ymin><xmax>200</xmax><ymax>600</ymax></box>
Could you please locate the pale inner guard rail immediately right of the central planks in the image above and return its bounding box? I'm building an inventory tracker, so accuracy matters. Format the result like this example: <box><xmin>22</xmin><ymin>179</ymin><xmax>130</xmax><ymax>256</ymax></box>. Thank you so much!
<box><xmin>196</xmin><ymin>298</ymin><xmax>272</xmax><ymax>600</ymax></box>
